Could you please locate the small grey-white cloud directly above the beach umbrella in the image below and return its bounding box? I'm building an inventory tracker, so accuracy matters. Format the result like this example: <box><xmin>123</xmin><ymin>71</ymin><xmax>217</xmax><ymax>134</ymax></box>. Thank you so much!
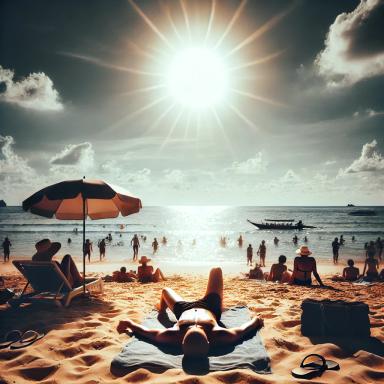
<box><xmin>49</xmin><ymin>142</ymin><xmax>95</xmax><ymax>168</ymax></box>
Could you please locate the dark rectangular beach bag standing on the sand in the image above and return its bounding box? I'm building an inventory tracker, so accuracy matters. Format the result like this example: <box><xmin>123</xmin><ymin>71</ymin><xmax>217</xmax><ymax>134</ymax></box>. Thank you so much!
<box><xmin>301</xmin><ymin>299</ymin><xmax>371</xmax><ymax>338</ymax></box>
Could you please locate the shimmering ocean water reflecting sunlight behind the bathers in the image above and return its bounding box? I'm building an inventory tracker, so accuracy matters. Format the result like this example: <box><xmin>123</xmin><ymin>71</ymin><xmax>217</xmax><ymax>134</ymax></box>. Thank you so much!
<box><xmin>0</xmin><ymin>206</ymin><xmax>384</xmax><ymax>268</ymax></box>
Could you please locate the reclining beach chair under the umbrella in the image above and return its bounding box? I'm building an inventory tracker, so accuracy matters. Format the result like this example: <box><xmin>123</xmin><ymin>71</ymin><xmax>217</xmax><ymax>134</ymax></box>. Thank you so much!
<box><xmin>9</xmin><ymin>260</ymin><xmax>103</xmax><ymax>307</ymax></box>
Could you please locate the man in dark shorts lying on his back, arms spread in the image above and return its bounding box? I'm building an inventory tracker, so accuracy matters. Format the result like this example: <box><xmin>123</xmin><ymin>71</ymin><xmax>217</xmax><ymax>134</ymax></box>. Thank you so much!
<box><xmin>117</xmin><ymin>268</ymin><xmax>264</xmax><ymax>358</ymax></box>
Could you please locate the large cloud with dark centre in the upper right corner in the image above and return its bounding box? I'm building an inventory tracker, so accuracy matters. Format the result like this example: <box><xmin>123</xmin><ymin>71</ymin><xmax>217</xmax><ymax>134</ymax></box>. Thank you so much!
<box><xmin>315</xmin><ymin>0</ymin><xmax>384</xmax><ymax>86</ymax></box>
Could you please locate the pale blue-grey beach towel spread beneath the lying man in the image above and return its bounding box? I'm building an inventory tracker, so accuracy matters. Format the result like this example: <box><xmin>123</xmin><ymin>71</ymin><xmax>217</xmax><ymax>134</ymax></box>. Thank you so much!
<box><xmin>111</xmin><ymin>307</ymin><xmax>271</xmax><ymax>375</ymax></box>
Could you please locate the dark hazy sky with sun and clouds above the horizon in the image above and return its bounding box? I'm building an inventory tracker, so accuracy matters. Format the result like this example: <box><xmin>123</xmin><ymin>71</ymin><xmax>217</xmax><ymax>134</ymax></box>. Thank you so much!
<box><xmin>0</xmin><ymin>0</ymin><xmax>384</xmax><ymax>206</ymax></box>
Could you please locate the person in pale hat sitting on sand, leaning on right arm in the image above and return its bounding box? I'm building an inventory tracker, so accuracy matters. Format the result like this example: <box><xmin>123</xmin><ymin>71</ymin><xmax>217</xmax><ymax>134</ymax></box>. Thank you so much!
<box><xmin>291</xmin><ymin>245</ymin><xmax>324</xmax><ymax>286</ymax></box>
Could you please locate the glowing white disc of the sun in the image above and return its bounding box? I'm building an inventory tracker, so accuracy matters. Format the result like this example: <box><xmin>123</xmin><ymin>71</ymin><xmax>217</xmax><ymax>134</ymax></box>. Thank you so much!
<box><xmin>166</xmin><ymin>47</ymin><xmax>229</xmax><ymax>109</ymax></box>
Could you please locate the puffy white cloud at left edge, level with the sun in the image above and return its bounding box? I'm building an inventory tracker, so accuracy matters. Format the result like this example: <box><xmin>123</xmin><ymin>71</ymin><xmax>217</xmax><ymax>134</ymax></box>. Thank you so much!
<box><xmin>0</xmin><ymin>66</ymin><xmax>63</xmax><ymax>111</ymax></box>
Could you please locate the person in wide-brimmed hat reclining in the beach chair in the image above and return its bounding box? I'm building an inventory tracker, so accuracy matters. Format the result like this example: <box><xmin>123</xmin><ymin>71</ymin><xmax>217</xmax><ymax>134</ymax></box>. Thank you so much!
<box><xmin>32</xmin><ymin>239</ymin><xmax>83</xmax><ymax>288</ymax></box>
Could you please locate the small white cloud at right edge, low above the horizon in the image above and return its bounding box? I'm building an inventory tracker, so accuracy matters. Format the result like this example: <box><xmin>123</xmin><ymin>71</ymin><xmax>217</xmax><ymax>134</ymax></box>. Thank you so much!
<box><xmin>339</xmin><ymin>140</ymin><xmax>384</xmax><ymax>175</ymax></box>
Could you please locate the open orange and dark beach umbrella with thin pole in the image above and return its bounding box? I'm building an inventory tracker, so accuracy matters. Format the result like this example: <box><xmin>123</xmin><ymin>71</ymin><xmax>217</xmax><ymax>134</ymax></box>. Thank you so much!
<box><xmin>23</xmin><ymin>178</ymin><xmax>142</xmax><ymax>292</ymax></box>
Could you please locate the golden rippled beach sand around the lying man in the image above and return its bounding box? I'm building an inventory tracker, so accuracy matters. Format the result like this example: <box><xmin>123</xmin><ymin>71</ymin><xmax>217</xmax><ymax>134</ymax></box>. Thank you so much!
<box><xmin>0</xmin><ymin>260</ymin><xmax>384</xmax><ymax>384</ymax></box>
